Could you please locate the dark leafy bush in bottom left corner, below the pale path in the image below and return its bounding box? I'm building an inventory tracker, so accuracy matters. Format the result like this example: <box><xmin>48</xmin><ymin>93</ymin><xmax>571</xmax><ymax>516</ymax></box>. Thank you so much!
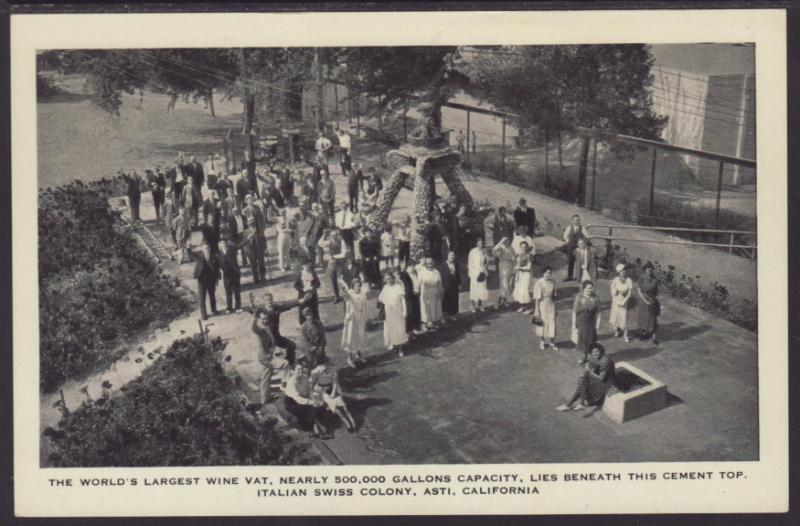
<box><xmin>44</xmin><ymin>335</ymin><xmax>315</xmax><ymax>467</ymax></box>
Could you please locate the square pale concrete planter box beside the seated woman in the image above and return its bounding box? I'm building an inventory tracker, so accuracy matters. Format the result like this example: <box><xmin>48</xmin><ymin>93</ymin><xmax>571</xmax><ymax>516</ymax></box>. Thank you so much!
<box><xmin>603</xmin><ymin>362</ymin><xmax>667</xmax><ymax>424</ymax></box>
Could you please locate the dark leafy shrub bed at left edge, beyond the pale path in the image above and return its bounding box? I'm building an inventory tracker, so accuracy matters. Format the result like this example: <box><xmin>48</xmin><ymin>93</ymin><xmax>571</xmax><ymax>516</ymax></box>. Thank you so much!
<box><xmin>38</xmin><ymin>181</ymin><xmax>189</xmax><ymax>391</ymax></box>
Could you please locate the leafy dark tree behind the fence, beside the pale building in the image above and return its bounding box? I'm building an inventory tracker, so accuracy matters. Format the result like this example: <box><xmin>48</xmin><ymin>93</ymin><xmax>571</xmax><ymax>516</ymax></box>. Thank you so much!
<box><xmin>464</xmin><ymin>44</ymin><xmax>666</xmax><ymax>203</ymax></box>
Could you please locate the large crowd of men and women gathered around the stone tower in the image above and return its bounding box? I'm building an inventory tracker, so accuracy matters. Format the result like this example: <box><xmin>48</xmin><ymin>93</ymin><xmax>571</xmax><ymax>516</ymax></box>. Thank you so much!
<box><xmin>121</xmin><ymin>126</ymin><xmax>660</xmax><ymax>437</ymax></box>
